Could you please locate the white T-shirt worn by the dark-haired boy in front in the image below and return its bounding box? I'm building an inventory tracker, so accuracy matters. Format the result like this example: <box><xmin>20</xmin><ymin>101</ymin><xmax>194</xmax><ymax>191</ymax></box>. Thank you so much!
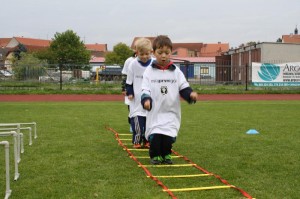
<box><xmin>142</xmin><ymin>65</ymin><xmax>190</xmax><ymax>139</ymax></box>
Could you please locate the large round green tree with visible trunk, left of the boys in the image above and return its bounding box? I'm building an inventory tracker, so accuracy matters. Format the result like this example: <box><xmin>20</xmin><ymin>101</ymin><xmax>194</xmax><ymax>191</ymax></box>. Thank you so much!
<box><xmin>49</xmin><ymin>30</ymin><xmax>91</xmax><ymax>90</ymax></box>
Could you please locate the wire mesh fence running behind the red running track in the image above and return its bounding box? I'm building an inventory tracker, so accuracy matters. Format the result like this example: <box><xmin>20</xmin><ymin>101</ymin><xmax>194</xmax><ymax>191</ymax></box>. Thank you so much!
<box><xmin>0</xmin><ymin>63</ymin><xmax>299</xmax><ymax>91</ymax></box>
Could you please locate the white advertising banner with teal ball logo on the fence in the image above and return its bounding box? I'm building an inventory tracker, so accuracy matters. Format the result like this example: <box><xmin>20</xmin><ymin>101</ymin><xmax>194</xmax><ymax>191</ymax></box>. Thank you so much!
<box><xmin>252</xmin><ymin>62</ymin><xmax>300</xmax><ymax>86</ymax></box>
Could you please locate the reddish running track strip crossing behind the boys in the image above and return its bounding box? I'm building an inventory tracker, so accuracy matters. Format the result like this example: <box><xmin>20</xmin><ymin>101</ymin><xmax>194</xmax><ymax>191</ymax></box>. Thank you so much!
<box><xmin>0</xmin><ymin>94</ymin><xmax>300</xmax><ymax>102</ymax></box>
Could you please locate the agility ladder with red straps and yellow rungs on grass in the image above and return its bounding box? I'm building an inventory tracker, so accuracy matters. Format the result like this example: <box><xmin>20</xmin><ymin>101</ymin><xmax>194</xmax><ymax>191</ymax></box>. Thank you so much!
<box><xmin>106</xmin><ymin>127</ymin><xmax>255</xmax><ymax>199</ymax></box>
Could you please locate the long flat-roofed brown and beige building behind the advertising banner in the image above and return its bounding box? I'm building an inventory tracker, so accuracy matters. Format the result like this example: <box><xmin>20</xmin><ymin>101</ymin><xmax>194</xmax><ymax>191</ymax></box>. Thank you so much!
<box><xmin>216</xmin><ymin>42</ymin><xmax>300</xmax><ymax>83</ymax></box>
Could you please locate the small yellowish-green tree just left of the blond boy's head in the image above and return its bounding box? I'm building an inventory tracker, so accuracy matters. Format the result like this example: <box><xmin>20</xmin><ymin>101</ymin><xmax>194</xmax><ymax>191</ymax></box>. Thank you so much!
<box><xmin>105</xmin><ymin>43</ymin><xmax>133</xmax><ymax>66</ymax></box>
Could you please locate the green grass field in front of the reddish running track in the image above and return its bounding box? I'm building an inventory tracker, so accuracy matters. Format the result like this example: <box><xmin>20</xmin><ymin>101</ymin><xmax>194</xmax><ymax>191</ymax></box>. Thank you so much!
<box><xmin>0</xmin><ymin>101</ymin><xmax>300</xmax><ymax>199</ymax></box>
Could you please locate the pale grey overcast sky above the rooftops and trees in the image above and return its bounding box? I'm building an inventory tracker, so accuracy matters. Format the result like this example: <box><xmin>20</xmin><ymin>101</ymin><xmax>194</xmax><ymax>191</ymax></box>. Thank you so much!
<box><xmin>0</xmin><ymin>0</ymin><xmax>300</xmax><ymax>50</ymax></box>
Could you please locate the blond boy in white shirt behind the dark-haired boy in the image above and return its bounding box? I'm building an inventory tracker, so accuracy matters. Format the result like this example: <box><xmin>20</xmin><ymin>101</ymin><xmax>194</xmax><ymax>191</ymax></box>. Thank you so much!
<box><xmin>126</xmin><ymin>38</ymin><xmax>153</xmax><ymax>148</ymax></box>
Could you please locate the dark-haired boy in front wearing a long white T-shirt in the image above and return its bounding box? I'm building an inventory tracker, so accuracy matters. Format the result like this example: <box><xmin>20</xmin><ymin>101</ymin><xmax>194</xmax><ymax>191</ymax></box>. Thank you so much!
<box><xmin>141</xmin><ymin>35</ymin><xmax>198</xmax><ymax>164</ymax></box>
